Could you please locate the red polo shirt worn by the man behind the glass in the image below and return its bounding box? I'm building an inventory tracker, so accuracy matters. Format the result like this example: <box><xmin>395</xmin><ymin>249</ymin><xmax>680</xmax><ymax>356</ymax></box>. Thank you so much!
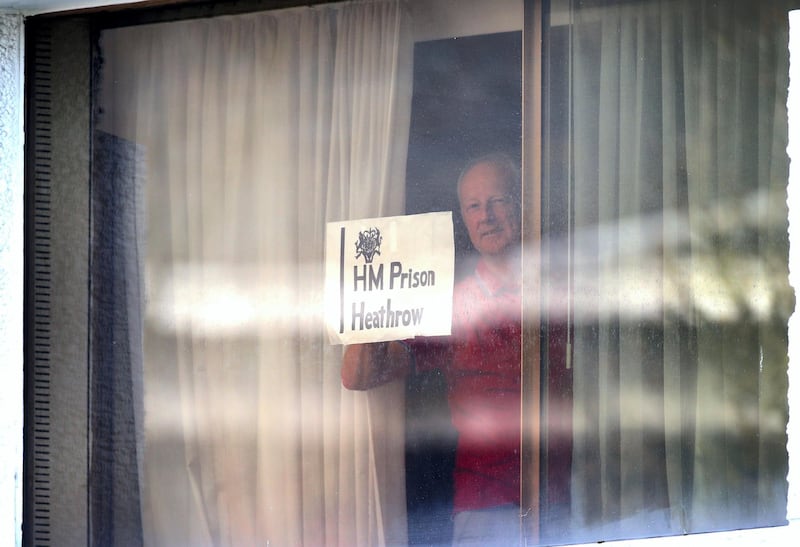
<box><xmin>413</xmin><ymin>260</ymin><xmax>522</xmax><ymax>513</ymax></box>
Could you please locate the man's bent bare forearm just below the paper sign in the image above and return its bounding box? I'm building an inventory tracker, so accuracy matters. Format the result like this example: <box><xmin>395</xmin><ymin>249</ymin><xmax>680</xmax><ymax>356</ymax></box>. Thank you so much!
<box><xmin>342</xmin><ymin>342</ymin><xmax>411</xmax><ymax>390</ymax></box>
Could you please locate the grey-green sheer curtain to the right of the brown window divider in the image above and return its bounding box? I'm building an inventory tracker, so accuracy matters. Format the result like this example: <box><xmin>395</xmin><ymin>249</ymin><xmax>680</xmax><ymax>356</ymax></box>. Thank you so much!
<box><xmin>571</xmin><ymin>0</ymin><xmax>793</xmax><ymax>540</ymax></box>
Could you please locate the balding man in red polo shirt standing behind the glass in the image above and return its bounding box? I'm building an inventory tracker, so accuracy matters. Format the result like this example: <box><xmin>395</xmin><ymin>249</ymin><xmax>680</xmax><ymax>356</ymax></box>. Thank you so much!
<box><xmin>342</xmin><ymin>154</ymin><xmax>521</xmax><ymax>545</ymax></box>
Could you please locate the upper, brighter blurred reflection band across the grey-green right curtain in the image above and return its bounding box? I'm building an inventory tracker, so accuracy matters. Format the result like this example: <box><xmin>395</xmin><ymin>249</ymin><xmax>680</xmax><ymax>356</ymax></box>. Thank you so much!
<box><xmin>548</xmin><ymin>189</ymin><xmax>794</xmax><ymax>323</ymax></box>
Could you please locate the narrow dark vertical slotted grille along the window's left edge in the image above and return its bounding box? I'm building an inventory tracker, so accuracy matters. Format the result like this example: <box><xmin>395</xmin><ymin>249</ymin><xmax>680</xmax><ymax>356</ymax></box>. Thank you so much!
<box><xmin>24</xmin><ymin>21</ymin><xmax>53</xmax><ymax>546</ymax></box>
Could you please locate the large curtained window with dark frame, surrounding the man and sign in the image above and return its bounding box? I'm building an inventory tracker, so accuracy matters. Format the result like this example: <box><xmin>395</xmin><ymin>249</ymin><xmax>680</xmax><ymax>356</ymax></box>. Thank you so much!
<box><xmin>24</xmin><ymin>0</ymin><xmax>796</xmax><ymax>545</ymax></box>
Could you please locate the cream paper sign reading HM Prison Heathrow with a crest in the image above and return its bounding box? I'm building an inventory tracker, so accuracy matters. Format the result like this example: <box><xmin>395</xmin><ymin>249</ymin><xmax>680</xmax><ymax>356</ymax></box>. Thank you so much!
<box><xmin>325</xmin><ymin>212</ymin><xmax>455</xmax><ymax>344</ymax></box>
